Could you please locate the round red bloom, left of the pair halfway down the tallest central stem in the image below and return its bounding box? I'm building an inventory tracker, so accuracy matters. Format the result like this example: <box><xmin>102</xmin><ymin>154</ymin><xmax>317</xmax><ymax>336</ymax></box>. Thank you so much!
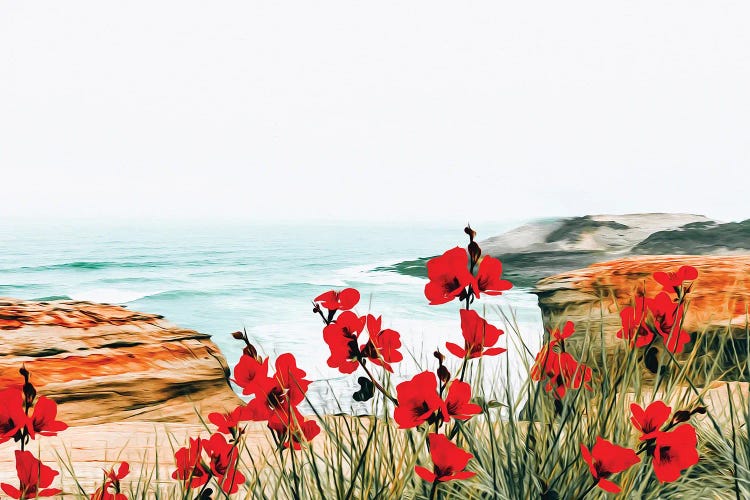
<box><xmin>393</xmin><ymin>372</ymin><xmax>443</xmax><ymax>429</ymax></box>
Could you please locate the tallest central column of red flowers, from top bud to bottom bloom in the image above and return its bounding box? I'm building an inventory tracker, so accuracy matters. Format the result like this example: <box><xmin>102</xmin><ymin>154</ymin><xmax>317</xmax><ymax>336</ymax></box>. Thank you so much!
<box><xmin>402</xmin><ymin>226</ymin><xmax>512</xmax><ymax>493</ymax></box>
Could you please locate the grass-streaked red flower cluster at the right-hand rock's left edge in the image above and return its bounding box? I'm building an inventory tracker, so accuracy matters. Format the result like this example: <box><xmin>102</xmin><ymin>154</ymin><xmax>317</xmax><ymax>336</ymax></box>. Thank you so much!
<box><xmin>531</xmin><ymin>321</ymin><xmax>592</xmax><ymax>400</ymax></box>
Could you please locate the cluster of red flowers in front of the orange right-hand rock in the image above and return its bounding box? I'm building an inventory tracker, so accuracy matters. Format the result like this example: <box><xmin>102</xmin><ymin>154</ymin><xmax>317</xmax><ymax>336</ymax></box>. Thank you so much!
<box><xmin>617</xmin><ymin>266</ymin><xmax>698</xmax><ymax>353</ymax></box>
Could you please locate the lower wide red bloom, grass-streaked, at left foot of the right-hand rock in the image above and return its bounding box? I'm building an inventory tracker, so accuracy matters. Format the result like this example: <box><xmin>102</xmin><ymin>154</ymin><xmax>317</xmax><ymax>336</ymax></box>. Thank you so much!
<box><xmin>531</xmin><ymin>344</ymin><xmax>592</xmax><ymax>399</ymax></box>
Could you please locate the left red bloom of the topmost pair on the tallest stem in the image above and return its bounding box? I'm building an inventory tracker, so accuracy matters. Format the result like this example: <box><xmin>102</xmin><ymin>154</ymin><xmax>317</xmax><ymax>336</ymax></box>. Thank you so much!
<box><xmin>424</xmin><ymin>247</ymin><xmax>474</xmax><ymax>305</ymax></box>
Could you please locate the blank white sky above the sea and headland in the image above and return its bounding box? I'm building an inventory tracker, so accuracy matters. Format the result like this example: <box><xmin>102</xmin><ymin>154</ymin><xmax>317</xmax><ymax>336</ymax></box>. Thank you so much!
<box><xmin>0</xmin><ymin>0</ymin><xmax>750</xmax><ymax>222</ymax></box>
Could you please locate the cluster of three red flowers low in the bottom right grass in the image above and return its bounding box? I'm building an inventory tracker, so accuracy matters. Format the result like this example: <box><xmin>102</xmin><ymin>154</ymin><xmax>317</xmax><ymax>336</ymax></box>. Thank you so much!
<box><xmin>581</xmin><ymin>401</ymin><xmax>705</xmax><ymax>493</ymax></box>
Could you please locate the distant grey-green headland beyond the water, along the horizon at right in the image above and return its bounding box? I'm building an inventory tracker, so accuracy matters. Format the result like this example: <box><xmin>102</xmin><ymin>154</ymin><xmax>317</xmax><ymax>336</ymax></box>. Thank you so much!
<box><xmin>378</xmin><ymin>214</ymin><xmax>750</xmax><ymax>287</ymax></box>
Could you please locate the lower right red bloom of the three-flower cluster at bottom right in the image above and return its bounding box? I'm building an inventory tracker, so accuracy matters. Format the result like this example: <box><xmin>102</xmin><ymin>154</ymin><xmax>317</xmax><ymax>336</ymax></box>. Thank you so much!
<box><xmin>654</xmin><ymin>424</ymin><xmax>699</xmax><ymax>483</ymax></box>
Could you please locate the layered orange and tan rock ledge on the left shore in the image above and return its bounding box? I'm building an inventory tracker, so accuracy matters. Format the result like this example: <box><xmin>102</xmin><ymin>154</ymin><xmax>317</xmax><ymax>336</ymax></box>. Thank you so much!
<box><xmin>0</xmin><ymin>299</ymin><xmax>240</xmax><ymax>425</ymax></box>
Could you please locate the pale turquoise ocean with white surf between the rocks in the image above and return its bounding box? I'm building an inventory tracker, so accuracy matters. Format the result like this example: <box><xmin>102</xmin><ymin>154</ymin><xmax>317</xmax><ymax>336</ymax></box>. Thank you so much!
<box><xmin>0</xmin><ymin>221</ymin><xmax>542</xmax><ymax>413</ymax></box>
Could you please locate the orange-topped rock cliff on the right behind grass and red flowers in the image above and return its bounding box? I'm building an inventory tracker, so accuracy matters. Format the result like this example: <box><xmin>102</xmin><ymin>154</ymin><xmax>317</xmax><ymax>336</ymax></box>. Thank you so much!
<box><xmin>535</xmin><ymin>255</ymin><xmax>750</xmax><ymax>380</ymax></box>
